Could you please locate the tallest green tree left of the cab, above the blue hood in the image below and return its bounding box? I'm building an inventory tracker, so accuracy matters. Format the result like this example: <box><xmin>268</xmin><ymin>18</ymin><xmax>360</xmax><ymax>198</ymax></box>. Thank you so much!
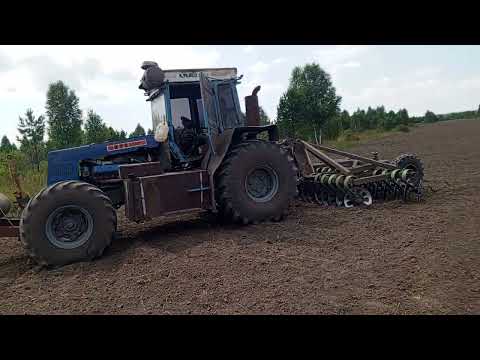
<box><xmin>46</xmin><ymin>81</ymin><xmax>83</xmax><ymax>149</ymax></box>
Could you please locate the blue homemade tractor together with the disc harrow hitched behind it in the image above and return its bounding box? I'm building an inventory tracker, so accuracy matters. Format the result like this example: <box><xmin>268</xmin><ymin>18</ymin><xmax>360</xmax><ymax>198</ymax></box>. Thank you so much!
<box><xmin>0</xmin><ymin>62</ymin><xmax>423</xmax><ymax>266</ymax></box>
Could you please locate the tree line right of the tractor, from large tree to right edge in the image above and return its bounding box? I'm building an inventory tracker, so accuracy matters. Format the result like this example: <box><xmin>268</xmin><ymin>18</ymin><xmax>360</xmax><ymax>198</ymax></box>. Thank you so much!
<box><xmin>276</xmin><ymin>63</ymin><xmax>480</xmax><ymax>142</ymax></box>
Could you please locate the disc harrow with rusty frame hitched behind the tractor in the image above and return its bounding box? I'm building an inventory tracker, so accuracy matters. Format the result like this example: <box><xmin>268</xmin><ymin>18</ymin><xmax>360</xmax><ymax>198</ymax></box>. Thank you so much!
<box><xmin>289</xmin><ymin>141</ymin><xmax>423</xmax><ymax>208</ymax></box>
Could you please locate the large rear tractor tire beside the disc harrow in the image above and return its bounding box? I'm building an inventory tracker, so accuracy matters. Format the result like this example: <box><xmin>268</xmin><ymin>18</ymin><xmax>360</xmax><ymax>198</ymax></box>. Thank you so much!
<box><xmin>215</xmin><ymin>140</ymin><xmax>297</xmax><ymax>224</ymax></box>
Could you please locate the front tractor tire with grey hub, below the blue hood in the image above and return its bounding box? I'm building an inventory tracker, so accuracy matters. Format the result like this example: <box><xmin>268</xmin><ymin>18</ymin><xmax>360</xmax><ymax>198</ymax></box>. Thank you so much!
<box><xmin>20</xmin><ymin>181</ymin><xmax>117</xmax><ymax>266</ymax></box>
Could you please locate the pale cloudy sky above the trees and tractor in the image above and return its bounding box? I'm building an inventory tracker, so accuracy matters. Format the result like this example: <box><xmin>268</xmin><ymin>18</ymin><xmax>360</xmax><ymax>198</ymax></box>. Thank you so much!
<box><xmin>0</xmin><ymin>45</ymin><xmax>480</xmax><ymax>144</ymax></box>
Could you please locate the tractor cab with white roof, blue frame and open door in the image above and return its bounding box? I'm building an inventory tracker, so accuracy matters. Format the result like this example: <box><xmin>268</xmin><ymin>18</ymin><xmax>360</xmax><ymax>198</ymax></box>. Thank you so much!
<box><xmin>139</xmin><ymin>62</ymin><xmax>245</xmax><ymax>163</ymax></box>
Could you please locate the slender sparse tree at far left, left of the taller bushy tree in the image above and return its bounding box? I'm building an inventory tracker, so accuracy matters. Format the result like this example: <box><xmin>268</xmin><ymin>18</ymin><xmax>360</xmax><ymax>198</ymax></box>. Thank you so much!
<box><xmin>17</xmin><ymin>109</ymin><xmax>46</xmax><ymax>171</ymax></box>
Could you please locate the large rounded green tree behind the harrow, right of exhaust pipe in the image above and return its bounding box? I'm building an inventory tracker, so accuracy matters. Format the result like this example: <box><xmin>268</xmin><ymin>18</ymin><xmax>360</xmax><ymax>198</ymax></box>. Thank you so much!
<box><xmin>277</xmin><ymin>63</ymin><xmax>342</xmax><ymax>138</ymax></box>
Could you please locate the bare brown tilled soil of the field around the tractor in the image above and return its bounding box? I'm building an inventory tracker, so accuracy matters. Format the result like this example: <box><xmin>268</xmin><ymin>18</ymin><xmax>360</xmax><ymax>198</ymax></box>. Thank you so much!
<box><xmin>0</xmin><ymin>121</ymin><xmax>480</xmax><ymax>314</ymax></box>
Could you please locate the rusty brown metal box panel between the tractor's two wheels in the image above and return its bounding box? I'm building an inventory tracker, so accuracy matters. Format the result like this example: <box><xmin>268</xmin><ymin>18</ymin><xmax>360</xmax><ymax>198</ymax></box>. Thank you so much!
<box><xmin>135</xmin><ymin>170</ymin><xmax>212</xmax><ymax>218</ymax></box>
